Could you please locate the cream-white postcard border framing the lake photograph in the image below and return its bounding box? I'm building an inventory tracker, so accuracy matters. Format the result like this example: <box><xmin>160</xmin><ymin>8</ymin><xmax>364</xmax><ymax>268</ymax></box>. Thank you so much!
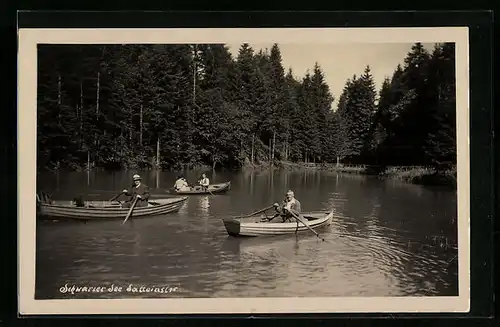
<box><xmin>18</xmin><ymin>27</ymin><xmax>470</xmax><ymax>315</ymax></box>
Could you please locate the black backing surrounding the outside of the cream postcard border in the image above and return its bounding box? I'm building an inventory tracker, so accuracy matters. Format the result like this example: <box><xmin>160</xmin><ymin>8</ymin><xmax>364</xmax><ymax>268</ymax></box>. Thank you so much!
<box><xmin>4</xmin><ymin>11</ymin><xmax>497</xmax><ymax>326</ymax></box>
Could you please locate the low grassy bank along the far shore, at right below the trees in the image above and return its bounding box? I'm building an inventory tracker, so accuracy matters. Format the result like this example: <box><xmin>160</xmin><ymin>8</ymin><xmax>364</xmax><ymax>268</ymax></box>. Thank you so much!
<box><xmin>243</xmin><ymin>161</ymin><xmax>457</xmax><ymax>188</ymax></box>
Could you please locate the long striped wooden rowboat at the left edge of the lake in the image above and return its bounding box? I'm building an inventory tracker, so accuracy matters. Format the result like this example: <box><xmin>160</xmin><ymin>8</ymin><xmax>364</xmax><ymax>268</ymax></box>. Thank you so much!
<box><xmin>39</xmin><ymin>197</ymin><xmax>187</xmax><ymax>220</ymax></box>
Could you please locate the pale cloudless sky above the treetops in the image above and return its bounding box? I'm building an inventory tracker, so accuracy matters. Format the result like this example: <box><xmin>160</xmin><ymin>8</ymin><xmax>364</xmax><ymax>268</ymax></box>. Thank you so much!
<box><xmin>227</xmin><ymin>43</ymin><xmax>434</xmax><ymax>106</ymax></box>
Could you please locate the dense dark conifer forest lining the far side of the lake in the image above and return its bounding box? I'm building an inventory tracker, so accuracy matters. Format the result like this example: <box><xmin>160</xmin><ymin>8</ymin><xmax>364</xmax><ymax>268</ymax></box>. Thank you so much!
<box><xmin>37</xmin><ymin>43</ymin><xmax>456</xmax><ymax>173</ymax></box>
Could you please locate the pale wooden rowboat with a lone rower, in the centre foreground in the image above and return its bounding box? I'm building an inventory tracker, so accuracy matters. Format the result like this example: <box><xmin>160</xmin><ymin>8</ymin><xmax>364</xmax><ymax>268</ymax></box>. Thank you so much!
<box><xmin>223</xmin><ymin>211</ymin><xmax>333</xmax><ymax>237</ymax></box>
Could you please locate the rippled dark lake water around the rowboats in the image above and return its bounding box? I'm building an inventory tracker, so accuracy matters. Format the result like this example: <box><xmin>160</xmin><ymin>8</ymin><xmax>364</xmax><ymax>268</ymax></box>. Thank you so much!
<box><xmin>35</xmin><ymin>170</ymin><xmax>458</xmax><ymax>299</ymax></box>
